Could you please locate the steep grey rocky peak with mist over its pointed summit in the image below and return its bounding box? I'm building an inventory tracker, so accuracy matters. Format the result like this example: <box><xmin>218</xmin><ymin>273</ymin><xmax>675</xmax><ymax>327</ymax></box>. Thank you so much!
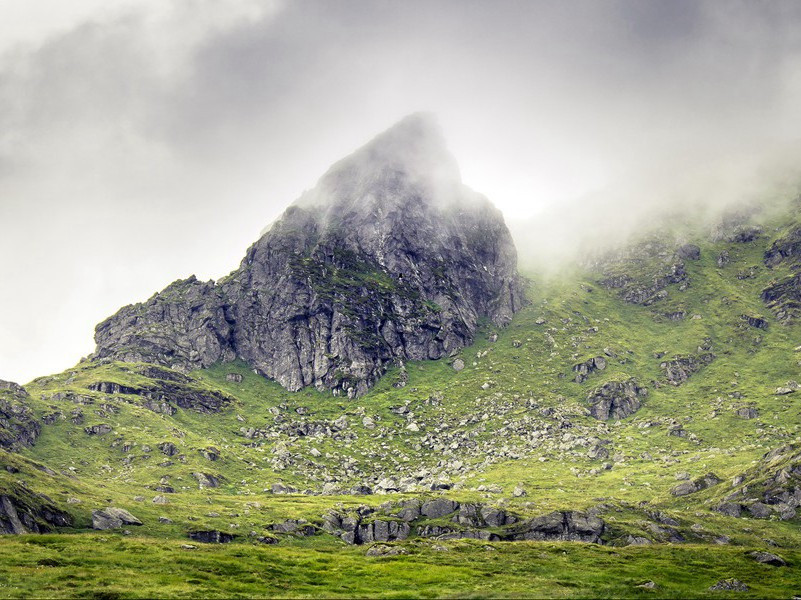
<box><xmin>95</xmin><ymin>115</ymin><xmax>525</xmax><ymax>396</ymax></box>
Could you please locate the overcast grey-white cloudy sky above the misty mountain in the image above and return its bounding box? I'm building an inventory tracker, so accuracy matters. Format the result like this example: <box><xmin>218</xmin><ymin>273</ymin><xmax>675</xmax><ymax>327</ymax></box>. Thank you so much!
<box><xmin>0</xmin><ymin>0</ymin><xmax>801</xmax><ymax>382</ymax></box>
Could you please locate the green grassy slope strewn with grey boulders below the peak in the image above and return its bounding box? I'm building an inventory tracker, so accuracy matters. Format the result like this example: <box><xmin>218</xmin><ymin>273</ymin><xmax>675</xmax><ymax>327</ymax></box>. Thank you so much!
<box><xmin>0</xmin><ymin>200</ymin><xmax>801</xmax><ymax>598</ymax></box>
